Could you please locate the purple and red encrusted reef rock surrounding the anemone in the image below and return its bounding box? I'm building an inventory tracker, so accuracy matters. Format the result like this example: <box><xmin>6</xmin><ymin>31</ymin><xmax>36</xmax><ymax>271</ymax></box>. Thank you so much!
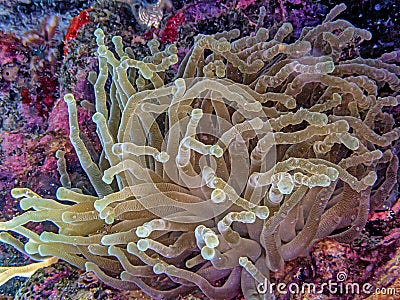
<box><xmin>0</xmin><ymin>0</ymin><xmax>400</xmax><ymax>299</ymax></box>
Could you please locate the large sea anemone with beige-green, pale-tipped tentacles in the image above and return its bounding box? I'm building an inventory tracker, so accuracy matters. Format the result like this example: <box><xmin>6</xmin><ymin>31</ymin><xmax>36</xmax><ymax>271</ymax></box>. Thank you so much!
<box><xmin>0</xmin><ymin>5</ymin><xmax>400</xmax><ymax>299</ymax></box>
